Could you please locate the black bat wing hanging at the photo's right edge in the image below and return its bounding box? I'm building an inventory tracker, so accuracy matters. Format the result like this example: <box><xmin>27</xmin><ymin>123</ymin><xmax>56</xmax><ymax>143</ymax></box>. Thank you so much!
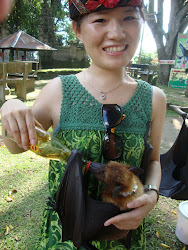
<box><xmin>159</xmin><ymin>119</ymin><xmax>188</xmax><ymax>200</ymax></box>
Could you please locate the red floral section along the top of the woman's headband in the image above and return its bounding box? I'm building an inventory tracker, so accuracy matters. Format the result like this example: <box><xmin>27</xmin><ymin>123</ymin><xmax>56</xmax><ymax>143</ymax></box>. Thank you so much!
<box><xmin>69</xmin><ymin>0</ymin><xmax>143</xmax><ymax>19</ymax></box>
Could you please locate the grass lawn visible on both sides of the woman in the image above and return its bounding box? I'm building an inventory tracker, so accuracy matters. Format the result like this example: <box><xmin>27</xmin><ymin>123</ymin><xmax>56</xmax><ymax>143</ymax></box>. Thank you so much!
<box><xmin>0</xmin><ymin>80</ymin><xmax>188</xmax><ymax>250</ymax></box>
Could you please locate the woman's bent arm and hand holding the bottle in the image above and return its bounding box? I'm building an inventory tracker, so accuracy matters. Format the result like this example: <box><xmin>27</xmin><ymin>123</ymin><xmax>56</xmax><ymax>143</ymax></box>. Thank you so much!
<box><xmin>1</xmin><ymin>78</ymin><xmax>62</xmax><ymax>154</ymax></box>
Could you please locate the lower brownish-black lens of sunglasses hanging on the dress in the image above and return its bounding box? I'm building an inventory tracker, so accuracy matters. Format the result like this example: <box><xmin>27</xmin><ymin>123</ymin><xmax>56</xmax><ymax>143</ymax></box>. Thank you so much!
<box><xmin>102</xmin><ymin>133</ymin><xmax>123</xmax><ymax>160</ymax></box>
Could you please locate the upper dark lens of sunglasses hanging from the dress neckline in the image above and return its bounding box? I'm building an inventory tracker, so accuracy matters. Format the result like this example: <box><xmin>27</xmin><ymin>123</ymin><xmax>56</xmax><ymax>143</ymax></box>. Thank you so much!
<box><xmin>102</xmin><ymin>104</ymin><xmax>122</xmax><ymax>128</ymax></box>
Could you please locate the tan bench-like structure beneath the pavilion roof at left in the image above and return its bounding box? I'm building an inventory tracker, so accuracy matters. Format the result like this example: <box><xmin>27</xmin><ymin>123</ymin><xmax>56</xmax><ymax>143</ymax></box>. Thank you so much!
<box><xmin>0</xmin><ymin>61</ymin><xmax>38</xmax><ymax>102</ymax></box>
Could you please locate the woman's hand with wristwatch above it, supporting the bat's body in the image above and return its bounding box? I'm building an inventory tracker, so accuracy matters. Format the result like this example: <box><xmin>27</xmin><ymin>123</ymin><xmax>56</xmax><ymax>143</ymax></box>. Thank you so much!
<box><xmin>104</xmin><ymin>190</ymin><xmax>157</xmax><ymax>230</ymax></box>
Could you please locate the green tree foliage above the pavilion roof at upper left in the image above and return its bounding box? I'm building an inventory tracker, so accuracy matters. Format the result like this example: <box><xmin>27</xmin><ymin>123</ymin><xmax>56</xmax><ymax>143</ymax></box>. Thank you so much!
<box><xmin>7</xmin><ymin>0</ymin><xmax>72</xmax><ymax>45</ymax></box>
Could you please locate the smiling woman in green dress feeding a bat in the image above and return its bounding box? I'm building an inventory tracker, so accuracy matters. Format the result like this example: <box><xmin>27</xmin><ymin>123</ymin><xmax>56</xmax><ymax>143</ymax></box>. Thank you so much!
<box><xmin>1</xmin><ymin>0</ymin><xmax>166</xmax><ymax>250</ymax></box>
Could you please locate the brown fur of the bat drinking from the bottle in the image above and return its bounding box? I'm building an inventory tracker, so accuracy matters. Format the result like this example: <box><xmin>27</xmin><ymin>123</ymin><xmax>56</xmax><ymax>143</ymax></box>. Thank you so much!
<box><xmin>89</xmin><ymin>161</ymin><xmax>144</xmax><ymax>241</ymax></box>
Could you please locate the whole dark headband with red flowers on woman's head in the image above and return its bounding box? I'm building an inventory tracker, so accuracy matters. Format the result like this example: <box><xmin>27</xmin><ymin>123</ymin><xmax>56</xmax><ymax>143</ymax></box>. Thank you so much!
<box><xmin>69</xmin><ymin>0</ymin><xmax>144</xmax><ymax>20</ymax></box>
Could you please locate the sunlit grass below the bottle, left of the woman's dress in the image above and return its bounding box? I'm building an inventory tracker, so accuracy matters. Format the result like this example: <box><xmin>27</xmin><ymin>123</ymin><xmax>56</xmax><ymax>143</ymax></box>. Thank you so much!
<box><xmin>0</xmin><ymin>147</ymin><xmax>49</xmax><ymax>249</ymax></box>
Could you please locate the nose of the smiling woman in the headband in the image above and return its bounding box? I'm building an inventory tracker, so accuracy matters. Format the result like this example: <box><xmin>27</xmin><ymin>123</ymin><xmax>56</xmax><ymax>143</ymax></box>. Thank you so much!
<box><xmin>108</xmin><ymin>21</ymin><xmax>125</xmax><ymax>40</ymax></box>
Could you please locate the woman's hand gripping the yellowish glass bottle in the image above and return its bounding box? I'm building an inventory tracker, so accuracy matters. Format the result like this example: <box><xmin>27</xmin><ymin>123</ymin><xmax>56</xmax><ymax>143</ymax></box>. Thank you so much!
<box><xmin>1</xmin><ymin>99</ymin><xmax>41</xmax><ymax>150</ymax></box>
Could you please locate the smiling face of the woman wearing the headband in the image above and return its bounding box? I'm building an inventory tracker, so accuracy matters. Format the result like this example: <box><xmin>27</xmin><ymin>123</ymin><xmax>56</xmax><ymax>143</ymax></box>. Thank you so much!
<box><xmin>73</xmin><ymin>7</ymin><xmax>143</xmax><ymax>69</ymax></box>
